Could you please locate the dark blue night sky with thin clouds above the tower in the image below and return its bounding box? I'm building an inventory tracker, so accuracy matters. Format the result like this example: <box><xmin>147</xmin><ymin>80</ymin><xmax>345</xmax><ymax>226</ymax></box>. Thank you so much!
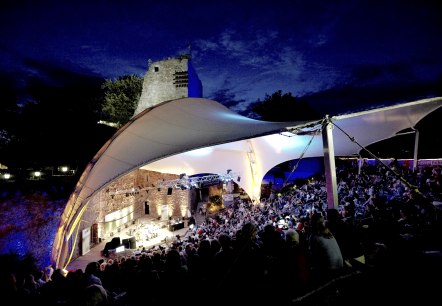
<box><xmin>0</xmin><ymin>0</ymin><xmax>442</xmax><ymax>113</ymax></box>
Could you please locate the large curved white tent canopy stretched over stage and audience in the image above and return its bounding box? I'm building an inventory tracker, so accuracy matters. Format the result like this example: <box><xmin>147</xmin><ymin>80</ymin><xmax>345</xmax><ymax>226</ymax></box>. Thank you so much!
<box><xmin>52</xmin><ymin>98</ymin><xmax>442</xmax><ymax>266</ymax></box>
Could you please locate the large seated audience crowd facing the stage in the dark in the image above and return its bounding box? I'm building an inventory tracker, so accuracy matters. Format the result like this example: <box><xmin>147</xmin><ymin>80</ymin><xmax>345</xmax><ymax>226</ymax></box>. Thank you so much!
<box><xmin>0</xmin><ymin>162</ymin><xmax>442</xmax><ymax>306</ymax></box>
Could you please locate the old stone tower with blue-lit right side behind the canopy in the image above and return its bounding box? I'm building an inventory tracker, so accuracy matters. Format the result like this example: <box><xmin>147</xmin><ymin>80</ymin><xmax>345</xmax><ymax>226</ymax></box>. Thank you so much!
<box><xmin>134</xmin><ymin>55</ymin><xmax>203</xmax><ymax>116</ymax></box>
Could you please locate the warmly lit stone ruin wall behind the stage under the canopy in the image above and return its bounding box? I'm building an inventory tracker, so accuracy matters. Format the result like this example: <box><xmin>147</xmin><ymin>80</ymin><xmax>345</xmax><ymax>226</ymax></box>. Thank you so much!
<box><xmin>73</xmin><ymin>170</ymin><xmax>197</xmax><ymax>258</ymax></box>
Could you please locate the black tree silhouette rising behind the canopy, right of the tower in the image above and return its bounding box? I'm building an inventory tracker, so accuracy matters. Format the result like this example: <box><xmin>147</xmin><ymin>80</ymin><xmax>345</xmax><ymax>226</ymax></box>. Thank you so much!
<box><xmin>252</xmin><ymin>90</ymin><xmax>323</xmax><ymax>122</ymax></box>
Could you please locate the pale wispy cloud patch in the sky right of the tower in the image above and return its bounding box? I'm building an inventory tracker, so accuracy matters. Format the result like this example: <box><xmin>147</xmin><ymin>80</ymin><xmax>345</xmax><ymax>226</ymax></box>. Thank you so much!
<box><xmin>193</xmin><ymin>29</ymin><xmax>338</xmax><ymax>109</ymax></box>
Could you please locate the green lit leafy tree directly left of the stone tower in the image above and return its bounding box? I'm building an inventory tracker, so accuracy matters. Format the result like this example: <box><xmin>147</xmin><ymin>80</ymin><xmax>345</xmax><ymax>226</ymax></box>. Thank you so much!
<box><xmin>101</xmin><ymin>75</ymin><xmax>143</xmax><ymax>127</ymax></box>
